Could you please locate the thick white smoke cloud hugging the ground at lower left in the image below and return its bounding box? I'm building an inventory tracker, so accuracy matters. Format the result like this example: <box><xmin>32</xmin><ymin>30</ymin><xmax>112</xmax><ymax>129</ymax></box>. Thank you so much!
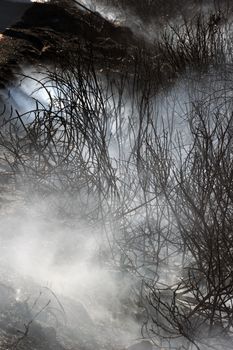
<box><xmin>0</xmin><ymin>193</ymin><xmax>144</xmax><ymax>347</ymax></box>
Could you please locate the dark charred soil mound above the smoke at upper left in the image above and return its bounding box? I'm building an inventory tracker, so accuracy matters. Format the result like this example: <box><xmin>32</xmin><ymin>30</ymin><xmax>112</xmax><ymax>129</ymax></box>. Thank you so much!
<box><xmin>0</xmin><ymin>1</ymin><xmax>141</xmax><ymax>88</ymax></box>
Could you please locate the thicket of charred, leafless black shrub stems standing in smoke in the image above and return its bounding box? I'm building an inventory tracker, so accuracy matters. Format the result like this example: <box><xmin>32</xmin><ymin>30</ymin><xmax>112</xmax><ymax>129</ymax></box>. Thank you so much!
<box><xmin>0</xmin><ymin>2</ymin><xmax>233</xmax><ymax>349</ymax></box>
